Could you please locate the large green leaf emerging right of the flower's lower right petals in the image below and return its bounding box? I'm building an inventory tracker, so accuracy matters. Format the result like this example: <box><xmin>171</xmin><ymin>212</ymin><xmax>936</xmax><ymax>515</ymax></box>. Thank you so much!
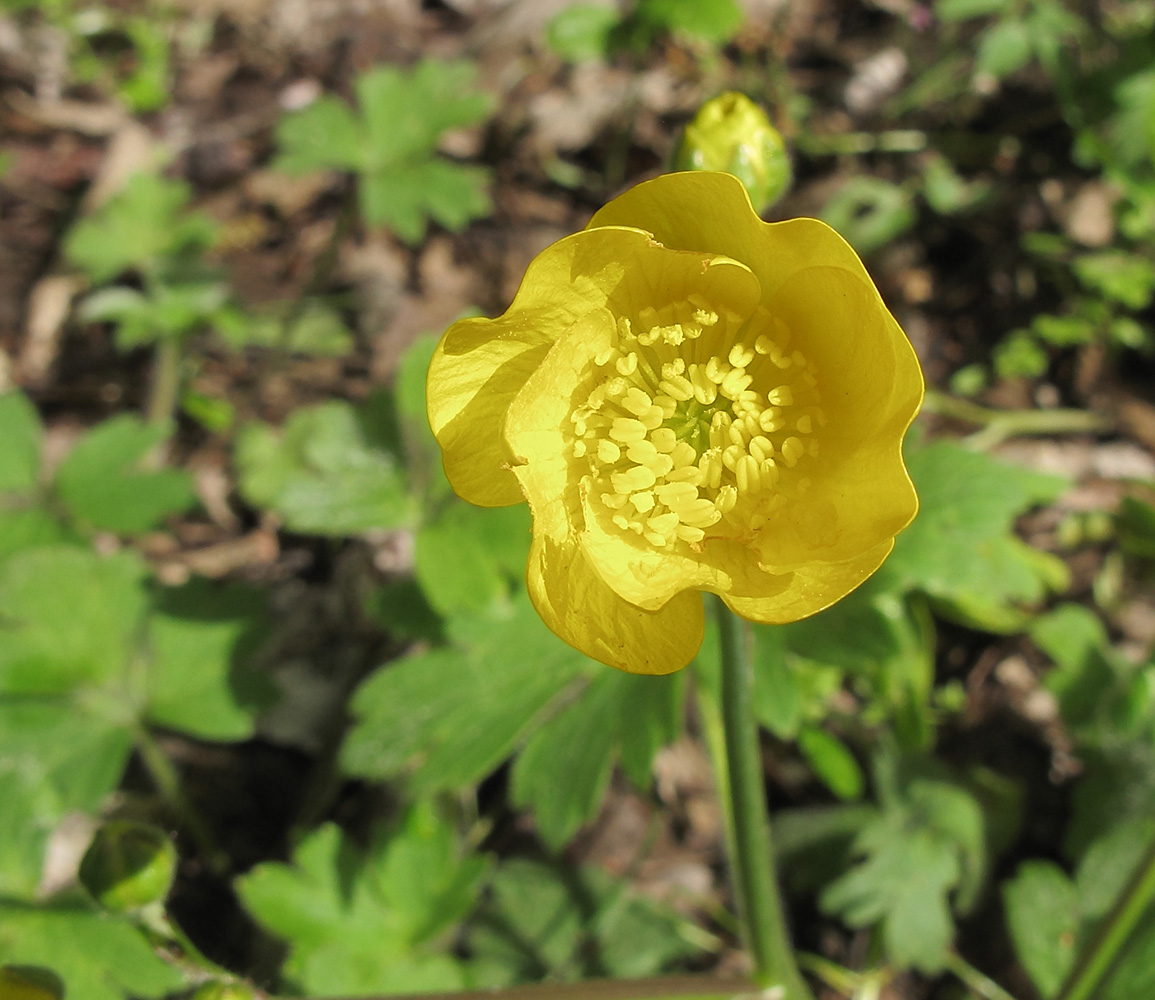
<box><xmin>877</xmin><ymin>441</ymin><xmax>1066</xmax><ymax>604</ymax></box>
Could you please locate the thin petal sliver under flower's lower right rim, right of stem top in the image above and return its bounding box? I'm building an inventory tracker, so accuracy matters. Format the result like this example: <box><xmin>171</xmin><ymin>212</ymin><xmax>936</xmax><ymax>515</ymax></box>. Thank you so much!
<box><xmin>721</xmin><ymin>538</ymin><xmax>894</xmax><ymax>625</ymax></box>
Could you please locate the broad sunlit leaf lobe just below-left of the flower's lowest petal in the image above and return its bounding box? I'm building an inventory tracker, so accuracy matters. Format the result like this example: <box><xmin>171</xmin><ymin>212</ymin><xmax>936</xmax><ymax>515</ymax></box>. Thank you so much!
<box><xmin>342</xmin><ymin>595</ymin><xmax>593</xmax><ymax>792</ymax></box>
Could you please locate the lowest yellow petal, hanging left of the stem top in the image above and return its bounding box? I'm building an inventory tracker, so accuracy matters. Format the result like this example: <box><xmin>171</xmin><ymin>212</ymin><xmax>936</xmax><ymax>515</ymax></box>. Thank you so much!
<box><xmin>526</xmin><ymin>532</ymin><xmax>703</xmax><ymax>674</ymax></box>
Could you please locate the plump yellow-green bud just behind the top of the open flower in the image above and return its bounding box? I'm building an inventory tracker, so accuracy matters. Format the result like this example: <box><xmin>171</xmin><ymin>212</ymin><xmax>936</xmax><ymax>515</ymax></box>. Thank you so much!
<box><xmin>673</xmin><ymin>90</ymin><xmax>790</xmax><ymax>212</ymax></box>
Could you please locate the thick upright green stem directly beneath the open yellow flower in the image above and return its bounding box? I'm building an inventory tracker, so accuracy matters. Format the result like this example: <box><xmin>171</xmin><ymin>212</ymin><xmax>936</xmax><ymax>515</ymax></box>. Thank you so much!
<box><xmin>716</xmin><ymin>600</ymin><xmax>811</xmax><ymax>1000</ymax></box>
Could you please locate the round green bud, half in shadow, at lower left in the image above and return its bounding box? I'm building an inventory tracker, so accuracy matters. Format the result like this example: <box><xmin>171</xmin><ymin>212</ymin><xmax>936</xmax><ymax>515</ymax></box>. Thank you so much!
<box><xmin>80</xmin><ymin>820</ymin><xmax>177</xmax><ymax>913</ymax></box>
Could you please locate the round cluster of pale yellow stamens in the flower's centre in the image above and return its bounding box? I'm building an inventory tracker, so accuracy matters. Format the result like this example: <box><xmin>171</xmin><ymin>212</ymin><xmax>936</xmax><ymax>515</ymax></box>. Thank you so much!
<box><xmin>571</xmin><ymin>294</ymin><xmax>826</xmax><ymax>548</ymax></box>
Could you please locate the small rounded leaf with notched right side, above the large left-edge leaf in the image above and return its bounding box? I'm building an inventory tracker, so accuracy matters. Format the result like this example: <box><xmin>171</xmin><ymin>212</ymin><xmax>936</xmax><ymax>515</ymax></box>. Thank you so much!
<box><xmin>55</xmin><ymin>413</ymin><xmax>196</xmax><ymax>535</ymax></box>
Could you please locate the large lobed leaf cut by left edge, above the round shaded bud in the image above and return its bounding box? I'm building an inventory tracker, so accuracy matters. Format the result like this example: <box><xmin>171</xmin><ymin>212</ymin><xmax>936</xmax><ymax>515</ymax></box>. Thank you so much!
<box><xmin>0</xmin><ymin>545</ymin><xmax>267</xmax><ymax>897</ymax></box>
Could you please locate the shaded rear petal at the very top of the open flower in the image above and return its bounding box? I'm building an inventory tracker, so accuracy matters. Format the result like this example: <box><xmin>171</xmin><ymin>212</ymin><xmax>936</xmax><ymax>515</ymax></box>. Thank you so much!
<box><xmin>589</xmin><ymin>171</ymin><xmax>877</xmax><ymax>301</ymax></box>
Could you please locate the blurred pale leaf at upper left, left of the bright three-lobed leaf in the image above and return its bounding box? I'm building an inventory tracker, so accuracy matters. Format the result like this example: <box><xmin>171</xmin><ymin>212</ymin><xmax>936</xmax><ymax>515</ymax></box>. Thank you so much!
<box><xmin>65</xmin><ymin>173</ymin><xmax>216</xmax><ymax>284</ymax></box>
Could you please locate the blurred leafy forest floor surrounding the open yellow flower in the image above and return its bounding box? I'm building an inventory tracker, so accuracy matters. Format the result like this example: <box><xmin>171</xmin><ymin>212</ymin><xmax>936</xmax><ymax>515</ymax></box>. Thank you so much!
<box><xmin>0</xmin><ymin>0</ymin><xmax>1155</xmax><ymax>1000</ymax></box>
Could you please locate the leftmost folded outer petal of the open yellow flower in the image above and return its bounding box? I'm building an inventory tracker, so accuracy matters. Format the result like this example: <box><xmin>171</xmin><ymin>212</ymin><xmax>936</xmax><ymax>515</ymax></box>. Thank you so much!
<box><xmin>426</xmin><ymin>227</ymin><xmax>665</xmax><ymax>507</ymax></box>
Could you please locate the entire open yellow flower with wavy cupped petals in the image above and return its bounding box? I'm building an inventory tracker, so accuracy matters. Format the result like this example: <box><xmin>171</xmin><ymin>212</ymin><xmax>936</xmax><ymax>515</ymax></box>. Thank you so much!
<box><xmin>427</xmin><ymin>172</ymin><xmax>923</xmax><ymax>673</ymax></box>
